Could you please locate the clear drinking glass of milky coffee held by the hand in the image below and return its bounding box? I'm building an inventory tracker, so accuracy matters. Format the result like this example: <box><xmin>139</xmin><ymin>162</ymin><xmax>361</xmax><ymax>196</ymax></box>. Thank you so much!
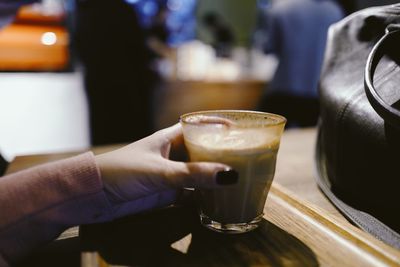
<box><xmin>181</xmin><ymin>110</ymin><xmax>286</xmax><ymax>233</ymax></box>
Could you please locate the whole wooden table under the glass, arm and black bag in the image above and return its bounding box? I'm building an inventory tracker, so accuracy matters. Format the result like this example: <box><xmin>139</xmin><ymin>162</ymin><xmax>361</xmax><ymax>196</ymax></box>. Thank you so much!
<box><xmin>9</xmin><ymin>129</ymin><xmax>400</xmax><ymax>266</ymax></box>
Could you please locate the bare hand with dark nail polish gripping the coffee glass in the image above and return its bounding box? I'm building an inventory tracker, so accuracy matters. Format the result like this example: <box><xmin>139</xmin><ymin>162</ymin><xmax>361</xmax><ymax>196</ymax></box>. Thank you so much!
<box><xmin>96</xmin><ymin>124</ymin><xmax>238</xmax><ymax>218</ymax></box>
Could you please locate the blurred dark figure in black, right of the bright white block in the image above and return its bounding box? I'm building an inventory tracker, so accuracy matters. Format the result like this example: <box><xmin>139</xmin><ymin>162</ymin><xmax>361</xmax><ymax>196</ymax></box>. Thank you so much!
<box><xmin>75</xmin><ymin>0</ymin><xmax>159</xmax><ymax>145</ymax></box>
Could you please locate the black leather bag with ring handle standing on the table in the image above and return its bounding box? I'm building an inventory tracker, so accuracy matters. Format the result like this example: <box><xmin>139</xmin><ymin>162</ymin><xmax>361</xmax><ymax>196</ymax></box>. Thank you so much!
<box><xmin>315</xmin><ymin>4</ymin><xmax>400</xmax><ymax>248</ymax></box>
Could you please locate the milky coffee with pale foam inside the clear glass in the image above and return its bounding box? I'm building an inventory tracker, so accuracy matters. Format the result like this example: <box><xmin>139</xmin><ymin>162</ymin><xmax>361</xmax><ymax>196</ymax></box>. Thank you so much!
<box><xmin>185</xmin><ymin>129</ymin><xmax>279</xmax><ymax>224</ymax></box>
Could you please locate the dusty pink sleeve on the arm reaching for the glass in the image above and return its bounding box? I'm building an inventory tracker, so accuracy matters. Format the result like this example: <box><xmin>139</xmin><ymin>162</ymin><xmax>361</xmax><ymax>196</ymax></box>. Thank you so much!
<box><xmin>0</xmin><ymin>152</ymin><xmax>111</xmax><ymax>266</ymax></box>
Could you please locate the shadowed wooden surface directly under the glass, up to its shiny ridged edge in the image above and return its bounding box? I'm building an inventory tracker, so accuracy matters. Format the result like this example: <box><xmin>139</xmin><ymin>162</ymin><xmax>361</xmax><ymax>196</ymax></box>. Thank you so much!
<box><xmin>77</xmin><ymin>184</ymin><xmax>400</xmax><ymax>266</ymax></box>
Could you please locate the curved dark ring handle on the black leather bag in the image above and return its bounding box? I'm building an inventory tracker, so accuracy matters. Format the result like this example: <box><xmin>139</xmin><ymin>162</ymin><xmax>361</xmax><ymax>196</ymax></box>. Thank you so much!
<box><xmin>364</xmin><ymin>24</ymin><xmax>400</xmax><ymax>127</ymax></box>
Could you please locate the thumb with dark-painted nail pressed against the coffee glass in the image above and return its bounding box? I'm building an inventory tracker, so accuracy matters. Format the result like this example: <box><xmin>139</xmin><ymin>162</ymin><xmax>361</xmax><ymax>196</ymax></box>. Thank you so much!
<box><xmin>167</xmin><ymin>161</ymin><xmax>239</xmax><ymax>188</ymax></box>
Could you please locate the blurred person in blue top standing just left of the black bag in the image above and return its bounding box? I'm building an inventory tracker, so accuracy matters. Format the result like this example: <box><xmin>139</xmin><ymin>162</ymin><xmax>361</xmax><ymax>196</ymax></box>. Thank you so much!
<box><xmin>258</xmin><ymin>0</ymin><xmax>345</xmax><ymax>127</ymax></box>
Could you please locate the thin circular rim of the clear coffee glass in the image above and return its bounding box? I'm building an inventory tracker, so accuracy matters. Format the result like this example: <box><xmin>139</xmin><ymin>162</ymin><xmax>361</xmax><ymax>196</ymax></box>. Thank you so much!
<box><xmin>179</xmin><ymin>109</ymin><xmax>287</xmax><ymax>127</ymax></box>
